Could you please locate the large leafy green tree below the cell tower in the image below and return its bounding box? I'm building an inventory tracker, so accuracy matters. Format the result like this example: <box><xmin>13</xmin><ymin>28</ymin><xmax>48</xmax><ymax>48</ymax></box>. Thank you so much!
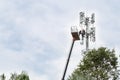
<box><xmin>68</xmin><ymin>47</ymin><xmax>119</xmax><ymax>80</ymax></box>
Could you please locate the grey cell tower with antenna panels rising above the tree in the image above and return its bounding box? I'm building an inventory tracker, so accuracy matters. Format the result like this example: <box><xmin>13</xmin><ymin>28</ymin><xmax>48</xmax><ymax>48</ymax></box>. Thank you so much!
<box><xmin>79</xmin><ymin>12</ymin><xmax>95</xmax><ymax>51</ymax></box>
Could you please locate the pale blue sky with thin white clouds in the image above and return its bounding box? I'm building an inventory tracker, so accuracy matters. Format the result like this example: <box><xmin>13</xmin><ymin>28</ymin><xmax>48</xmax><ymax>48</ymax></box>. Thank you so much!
<box><xmin>0</xmin><ymin>0</ymin><xmax>120</xmax><ymax>80</ymax></box>
